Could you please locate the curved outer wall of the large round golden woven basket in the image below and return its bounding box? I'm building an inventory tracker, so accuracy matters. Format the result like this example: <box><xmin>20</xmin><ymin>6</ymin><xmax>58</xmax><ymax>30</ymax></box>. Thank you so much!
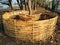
<box><xmin>3</xmin><ymin>11</ymin><xmax>58</xmax><ymax>42</ymax></box>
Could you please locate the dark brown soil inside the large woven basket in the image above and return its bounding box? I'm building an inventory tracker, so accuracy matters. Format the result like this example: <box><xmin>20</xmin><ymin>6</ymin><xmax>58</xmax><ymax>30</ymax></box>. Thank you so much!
<box><xmin>12</xmin><ymin>12</ymin><xmax>53</xmax><ymax>21</ymax></box>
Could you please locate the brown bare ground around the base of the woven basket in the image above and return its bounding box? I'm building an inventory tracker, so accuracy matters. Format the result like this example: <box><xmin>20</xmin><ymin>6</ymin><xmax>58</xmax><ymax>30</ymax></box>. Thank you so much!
<box><xmin>0</xmin><ymin>7</ymin><xmax>60</xmax><ymax>45</ymax></box>
